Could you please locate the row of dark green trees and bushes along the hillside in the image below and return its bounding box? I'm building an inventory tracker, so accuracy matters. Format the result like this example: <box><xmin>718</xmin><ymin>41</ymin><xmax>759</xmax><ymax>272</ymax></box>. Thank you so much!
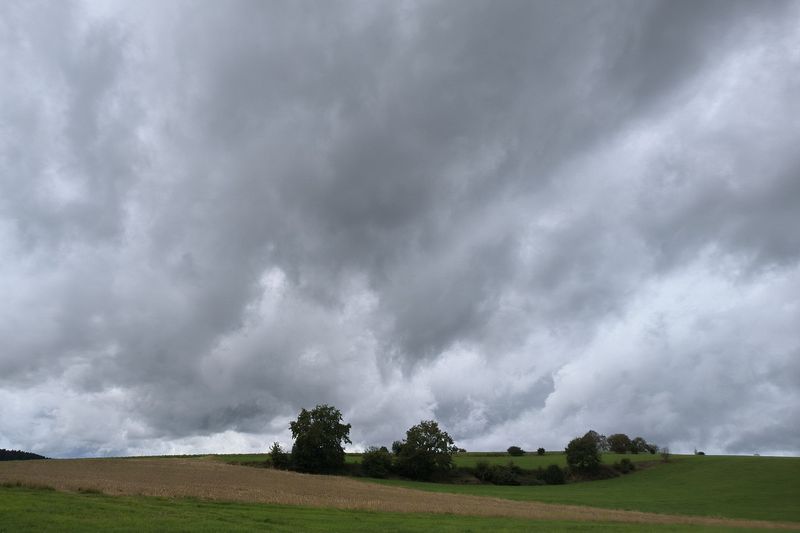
<box><xmin>269</xmin><ymin>404</ymin><xmax>668</xmax><ymax>485</ymax></box>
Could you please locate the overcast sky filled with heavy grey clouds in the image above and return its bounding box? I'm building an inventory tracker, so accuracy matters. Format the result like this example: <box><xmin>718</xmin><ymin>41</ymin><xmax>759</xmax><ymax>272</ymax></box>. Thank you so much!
<box><xmin>0</xmin><ymin>0</ymin><xmax>800</xmax><ymax>457</ymax></box>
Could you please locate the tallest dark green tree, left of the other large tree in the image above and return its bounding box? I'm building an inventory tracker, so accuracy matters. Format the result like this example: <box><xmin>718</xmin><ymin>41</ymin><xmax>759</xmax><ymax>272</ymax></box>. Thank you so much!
<box><xmin>289</xmin><ymin>405</ymin><xmax>351</xmax><ymax>473</ymax></box>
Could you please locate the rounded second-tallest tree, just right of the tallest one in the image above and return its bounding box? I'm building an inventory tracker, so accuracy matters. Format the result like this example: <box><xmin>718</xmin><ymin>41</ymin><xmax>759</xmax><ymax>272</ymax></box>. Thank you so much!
<box><xmin>392</xmin><ymin>420</ymin><xmax>458</xmax><ymax>479</ymax></box>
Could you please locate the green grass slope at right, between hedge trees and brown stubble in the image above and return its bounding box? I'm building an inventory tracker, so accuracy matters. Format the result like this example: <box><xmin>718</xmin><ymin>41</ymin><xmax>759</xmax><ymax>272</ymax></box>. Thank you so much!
<box><xmin>364</xmin><ymin>456</ymin><xmax>800</xmax><ymax>522</ymax></box>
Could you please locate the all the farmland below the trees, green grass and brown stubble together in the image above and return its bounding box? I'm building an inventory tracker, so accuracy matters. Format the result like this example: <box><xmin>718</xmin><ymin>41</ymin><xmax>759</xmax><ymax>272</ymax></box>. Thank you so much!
<box><xmin>0</xmin><ymin>450</ymin><xmax>800</xmax><ymax>531</ymax></box>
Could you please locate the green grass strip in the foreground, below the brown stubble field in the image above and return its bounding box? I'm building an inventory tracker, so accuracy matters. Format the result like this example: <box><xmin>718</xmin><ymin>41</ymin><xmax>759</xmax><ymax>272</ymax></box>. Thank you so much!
<box><xmin>0</xmin><ymin>486</ymin><xmax>764</xmax><ymax>532</ymax></box>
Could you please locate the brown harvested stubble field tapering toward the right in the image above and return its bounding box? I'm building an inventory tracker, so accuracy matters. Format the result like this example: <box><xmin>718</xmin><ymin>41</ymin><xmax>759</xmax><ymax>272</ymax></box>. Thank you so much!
<box><xmin>0</xmin><ymin>459</ymin><xmax>797</xmax><ymax>528</ymax></box>
